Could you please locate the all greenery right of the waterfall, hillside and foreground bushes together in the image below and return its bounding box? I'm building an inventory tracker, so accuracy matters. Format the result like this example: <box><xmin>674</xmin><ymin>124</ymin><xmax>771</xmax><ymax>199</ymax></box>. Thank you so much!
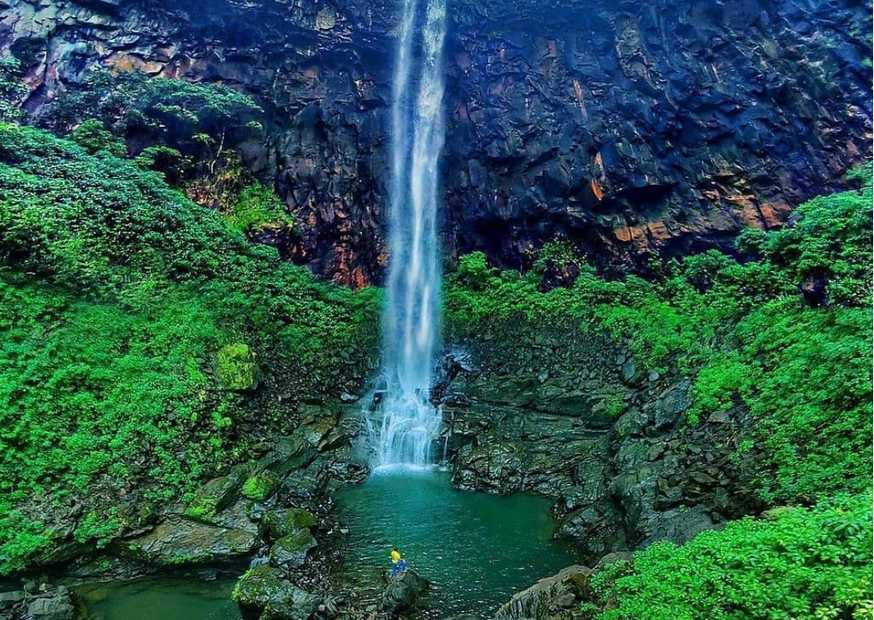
<box><xmin>445</xmin><ymin>166</ymin><xmax>872</xmax><ymax>620</ymax></box>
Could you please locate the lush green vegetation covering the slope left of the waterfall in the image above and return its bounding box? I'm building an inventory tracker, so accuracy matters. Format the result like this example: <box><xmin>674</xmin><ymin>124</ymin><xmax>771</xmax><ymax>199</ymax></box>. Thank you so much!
<box><xmin>0</xmin><ymin>124</ymin><xmax>377</xmax><ymax>571</ymax></box>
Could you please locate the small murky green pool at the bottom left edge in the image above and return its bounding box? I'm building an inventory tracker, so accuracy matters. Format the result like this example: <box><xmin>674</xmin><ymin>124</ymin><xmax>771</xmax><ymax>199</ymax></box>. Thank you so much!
<box><xmin>76</xmin><ymin>577</ymin><xmax>240</xmax><ymax>620</ymax></box>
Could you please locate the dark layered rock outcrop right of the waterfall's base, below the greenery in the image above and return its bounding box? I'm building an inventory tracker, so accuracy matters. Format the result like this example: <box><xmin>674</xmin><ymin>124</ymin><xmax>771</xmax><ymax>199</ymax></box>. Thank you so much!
<box><xmin>442</xmin><ymin>326</ymin><xmax>756</xmax><ymax>561</ymax></box>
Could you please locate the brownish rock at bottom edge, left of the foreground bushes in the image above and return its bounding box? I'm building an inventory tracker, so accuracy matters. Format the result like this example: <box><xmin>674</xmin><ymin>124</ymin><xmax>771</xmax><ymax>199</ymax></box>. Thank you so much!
<box><xmin>495</xmin><ymin>565</ymin><xmax>592</xmax><ymax>620</ymax></box>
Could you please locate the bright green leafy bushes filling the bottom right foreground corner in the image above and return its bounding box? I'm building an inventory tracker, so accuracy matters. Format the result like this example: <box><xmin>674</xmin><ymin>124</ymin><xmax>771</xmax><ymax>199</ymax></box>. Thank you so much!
<box><xmin>581</xmin><ymin>494</ymin><xmax>872</xmax><ymax>620</ymax></box>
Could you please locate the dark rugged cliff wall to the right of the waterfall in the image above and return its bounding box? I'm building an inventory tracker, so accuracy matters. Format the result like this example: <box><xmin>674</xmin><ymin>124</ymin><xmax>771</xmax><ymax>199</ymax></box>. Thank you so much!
<box><xmin>446</xmin><ymin>0</ymin><xmax>871</xmax><ymax>269</ymax></box>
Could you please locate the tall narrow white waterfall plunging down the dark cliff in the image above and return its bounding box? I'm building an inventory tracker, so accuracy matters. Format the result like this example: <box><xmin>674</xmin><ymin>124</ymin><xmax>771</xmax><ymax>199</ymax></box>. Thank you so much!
<box><xmin>373</xmin><ymin>0</ymin><xmax>446</xmax><ymax>466</ymax></box>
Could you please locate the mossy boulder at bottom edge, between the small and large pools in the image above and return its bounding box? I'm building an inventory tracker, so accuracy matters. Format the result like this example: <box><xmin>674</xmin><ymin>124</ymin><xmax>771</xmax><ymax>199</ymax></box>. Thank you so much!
<box><xmin>233</xmin><ymin>564</ymin><xmax>320</xmax><ymax>620</ymax></box>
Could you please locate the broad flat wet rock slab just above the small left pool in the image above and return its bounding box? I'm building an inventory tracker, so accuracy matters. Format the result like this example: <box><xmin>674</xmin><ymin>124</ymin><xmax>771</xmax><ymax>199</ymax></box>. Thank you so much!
<box><xmin>119</xmin><ymin>516</ymin><xmax>257</xmax><ymax>567</ymax></box>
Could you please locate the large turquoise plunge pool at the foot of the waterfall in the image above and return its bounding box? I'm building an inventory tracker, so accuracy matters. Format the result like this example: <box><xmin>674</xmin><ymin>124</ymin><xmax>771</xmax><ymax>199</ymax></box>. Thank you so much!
<box><xmin>337</xmin><ymin>470</ymin><xmax>575</xmax><ymax>617</ymax></box>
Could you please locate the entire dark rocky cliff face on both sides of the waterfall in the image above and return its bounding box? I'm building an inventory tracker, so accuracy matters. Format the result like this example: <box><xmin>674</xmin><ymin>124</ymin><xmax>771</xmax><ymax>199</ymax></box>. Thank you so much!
<box><xmin>0</xmin><ymin>0</ymin><xmax>871</xmax><ymax>285</ymax></box>
